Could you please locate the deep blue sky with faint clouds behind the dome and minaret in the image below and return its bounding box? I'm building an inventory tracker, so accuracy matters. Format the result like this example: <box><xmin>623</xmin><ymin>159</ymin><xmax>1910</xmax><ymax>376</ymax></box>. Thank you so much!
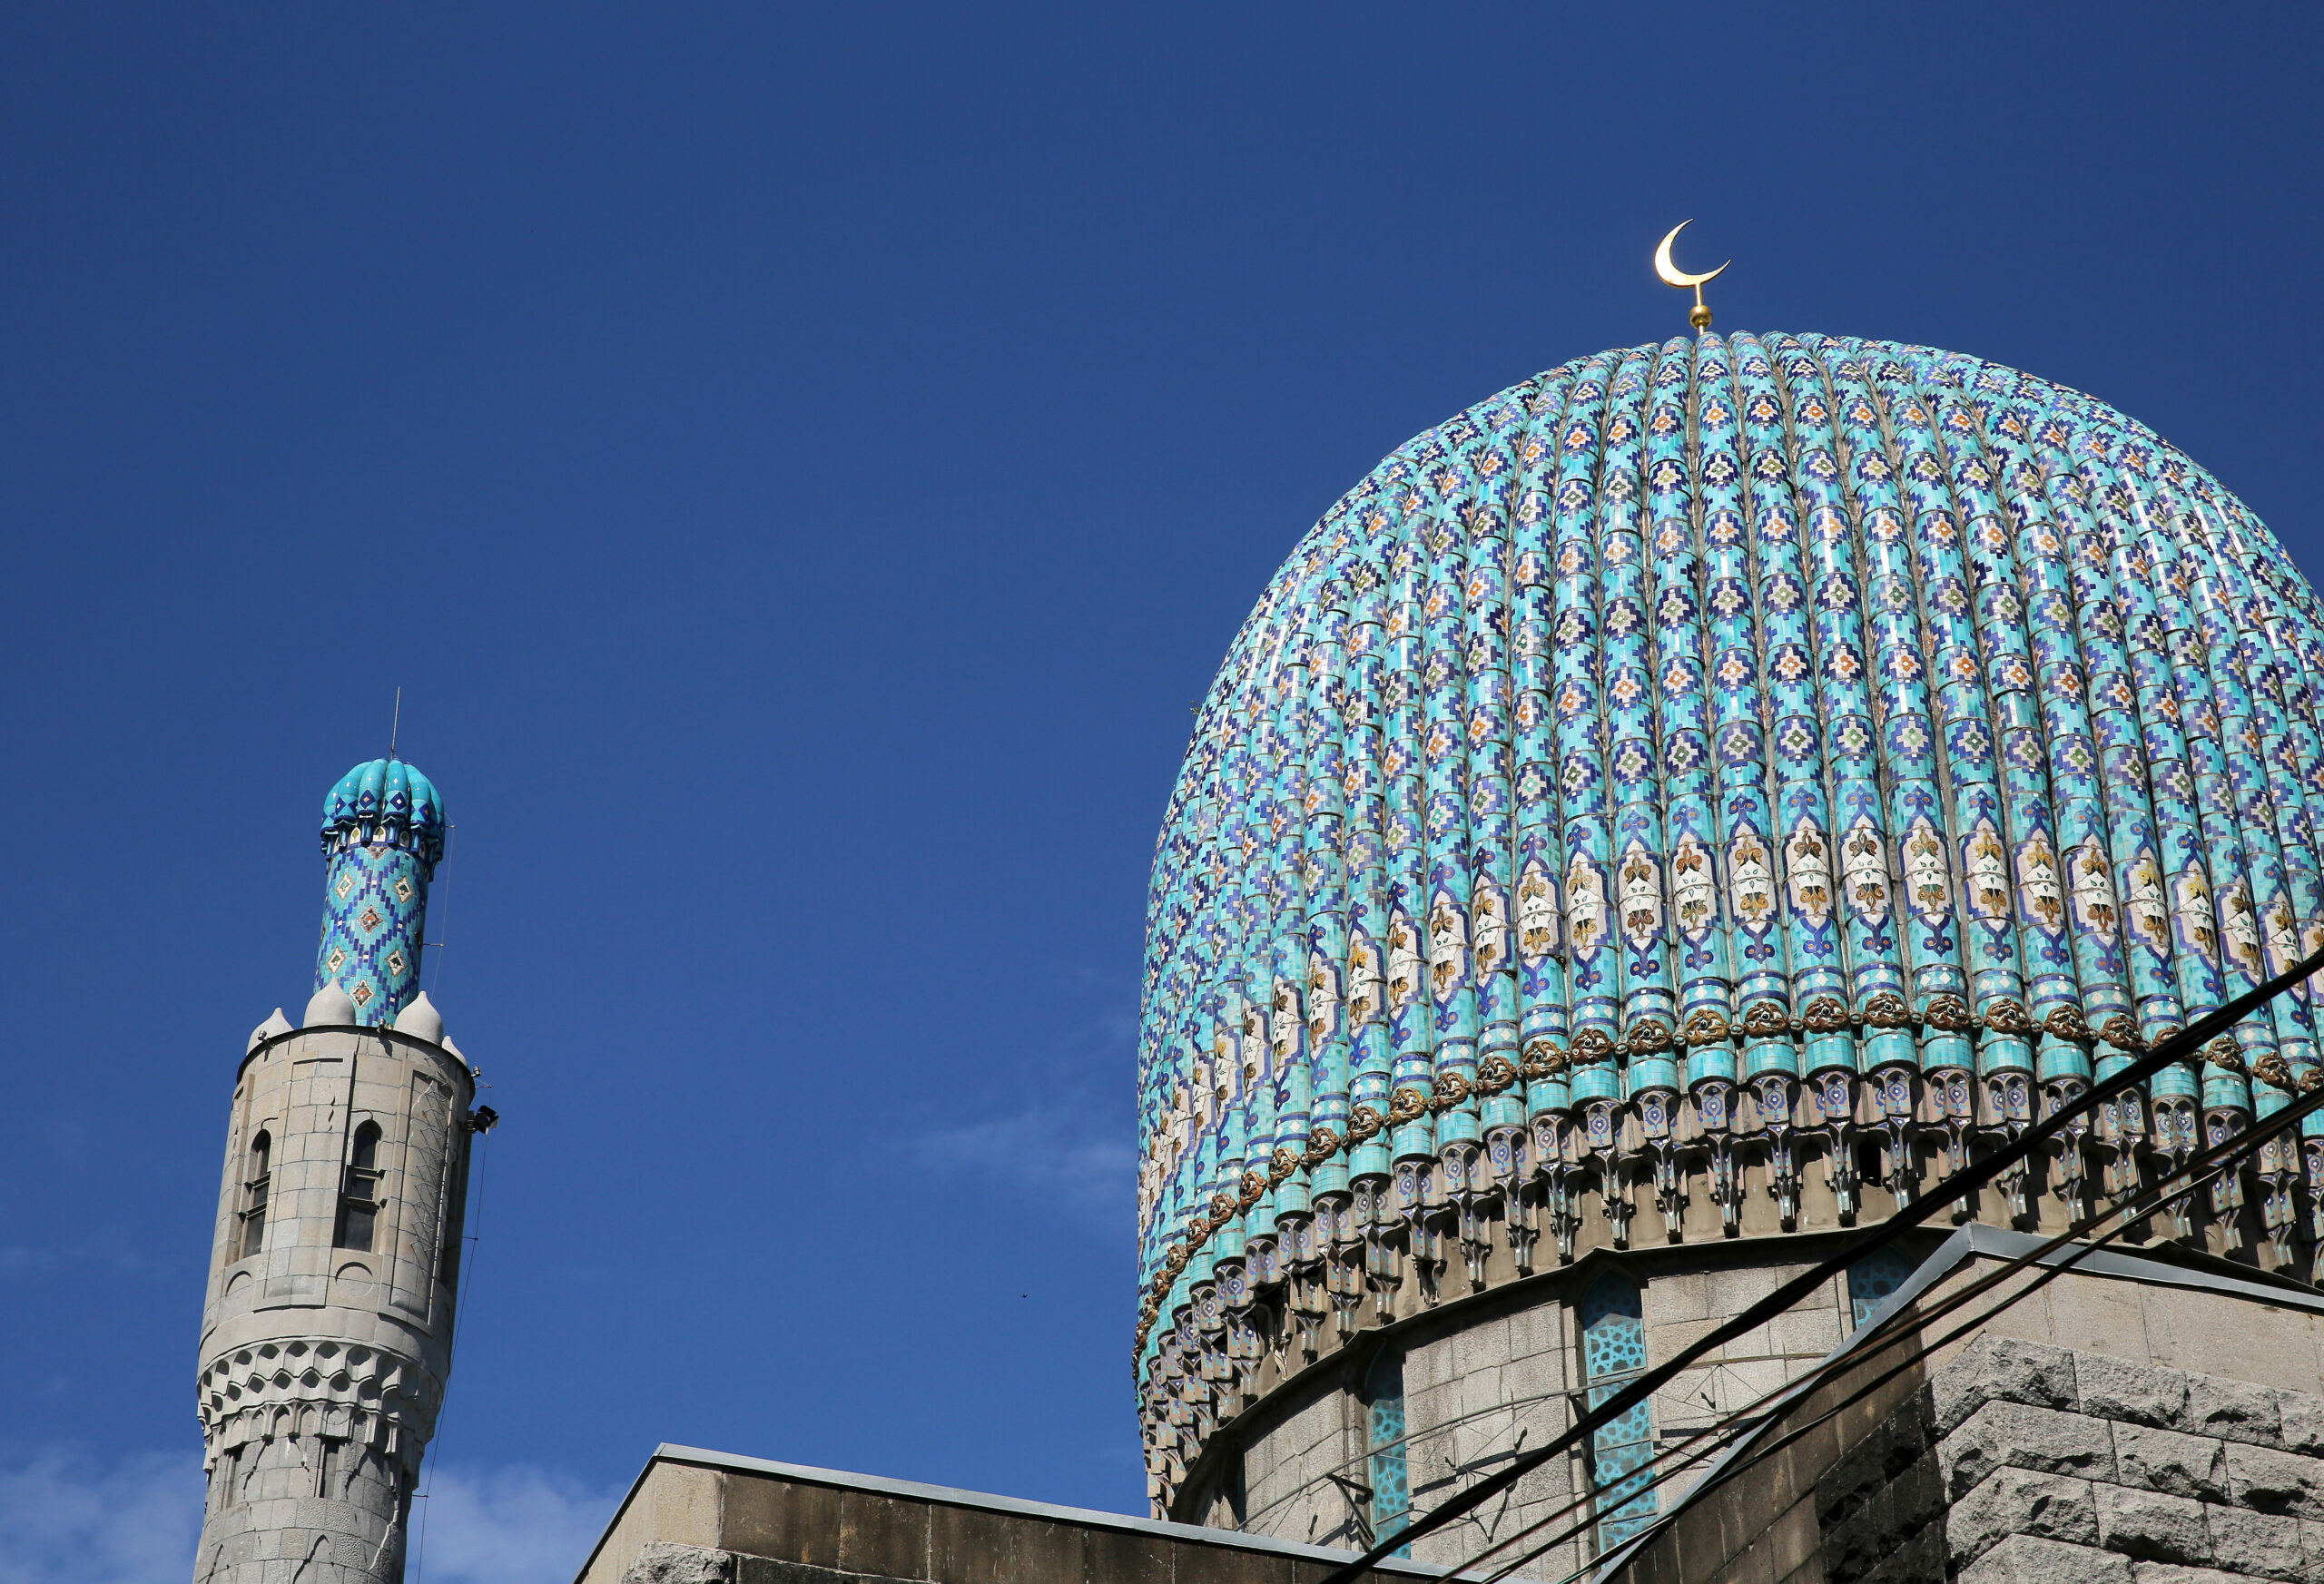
<box><xmin>0</xmin><ymin>5</ymin><xmax>2324</xmax><ymax>1584</ymax></box>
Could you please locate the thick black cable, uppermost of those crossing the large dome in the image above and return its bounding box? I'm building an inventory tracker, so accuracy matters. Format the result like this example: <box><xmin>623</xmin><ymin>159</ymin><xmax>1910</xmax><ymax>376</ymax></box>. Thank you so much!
<box><xmin>1320</xmin><ymin>949</ymin><xmax>2324</xmax><ymax>1584</ymax></box>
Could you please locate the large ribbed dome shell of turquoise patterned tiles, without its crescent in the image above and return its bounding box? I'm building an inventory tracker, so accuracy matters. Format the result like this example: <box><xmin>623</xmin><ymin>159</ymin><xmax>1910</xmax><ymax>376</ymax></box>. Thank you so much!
<box><xmin>1138</xmin><ymin>334</ymin><xmax>2324</xmax><ymax>1343</ymax></box>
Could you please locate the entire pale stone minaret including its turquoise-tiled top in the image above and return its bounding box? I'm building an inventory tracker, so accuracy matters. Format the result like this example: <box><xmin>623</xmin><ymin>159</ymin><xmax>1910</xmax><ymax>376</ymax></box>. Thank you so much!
<box><xmin>192</xmin><ymin>760</ymin><xmax>493</xmax><ymax>1584</ymax></box>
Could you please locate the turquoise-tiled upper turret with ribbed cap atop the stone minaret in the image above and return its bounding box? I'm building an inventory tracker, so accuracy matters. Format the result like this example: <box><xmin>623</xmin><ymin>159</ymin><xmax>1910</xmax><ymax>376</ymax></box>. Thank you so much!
<box><xmin>314</xmin><ymin>760</ymin><xmax>447</xmax><ymax>1024</ymax></box>
